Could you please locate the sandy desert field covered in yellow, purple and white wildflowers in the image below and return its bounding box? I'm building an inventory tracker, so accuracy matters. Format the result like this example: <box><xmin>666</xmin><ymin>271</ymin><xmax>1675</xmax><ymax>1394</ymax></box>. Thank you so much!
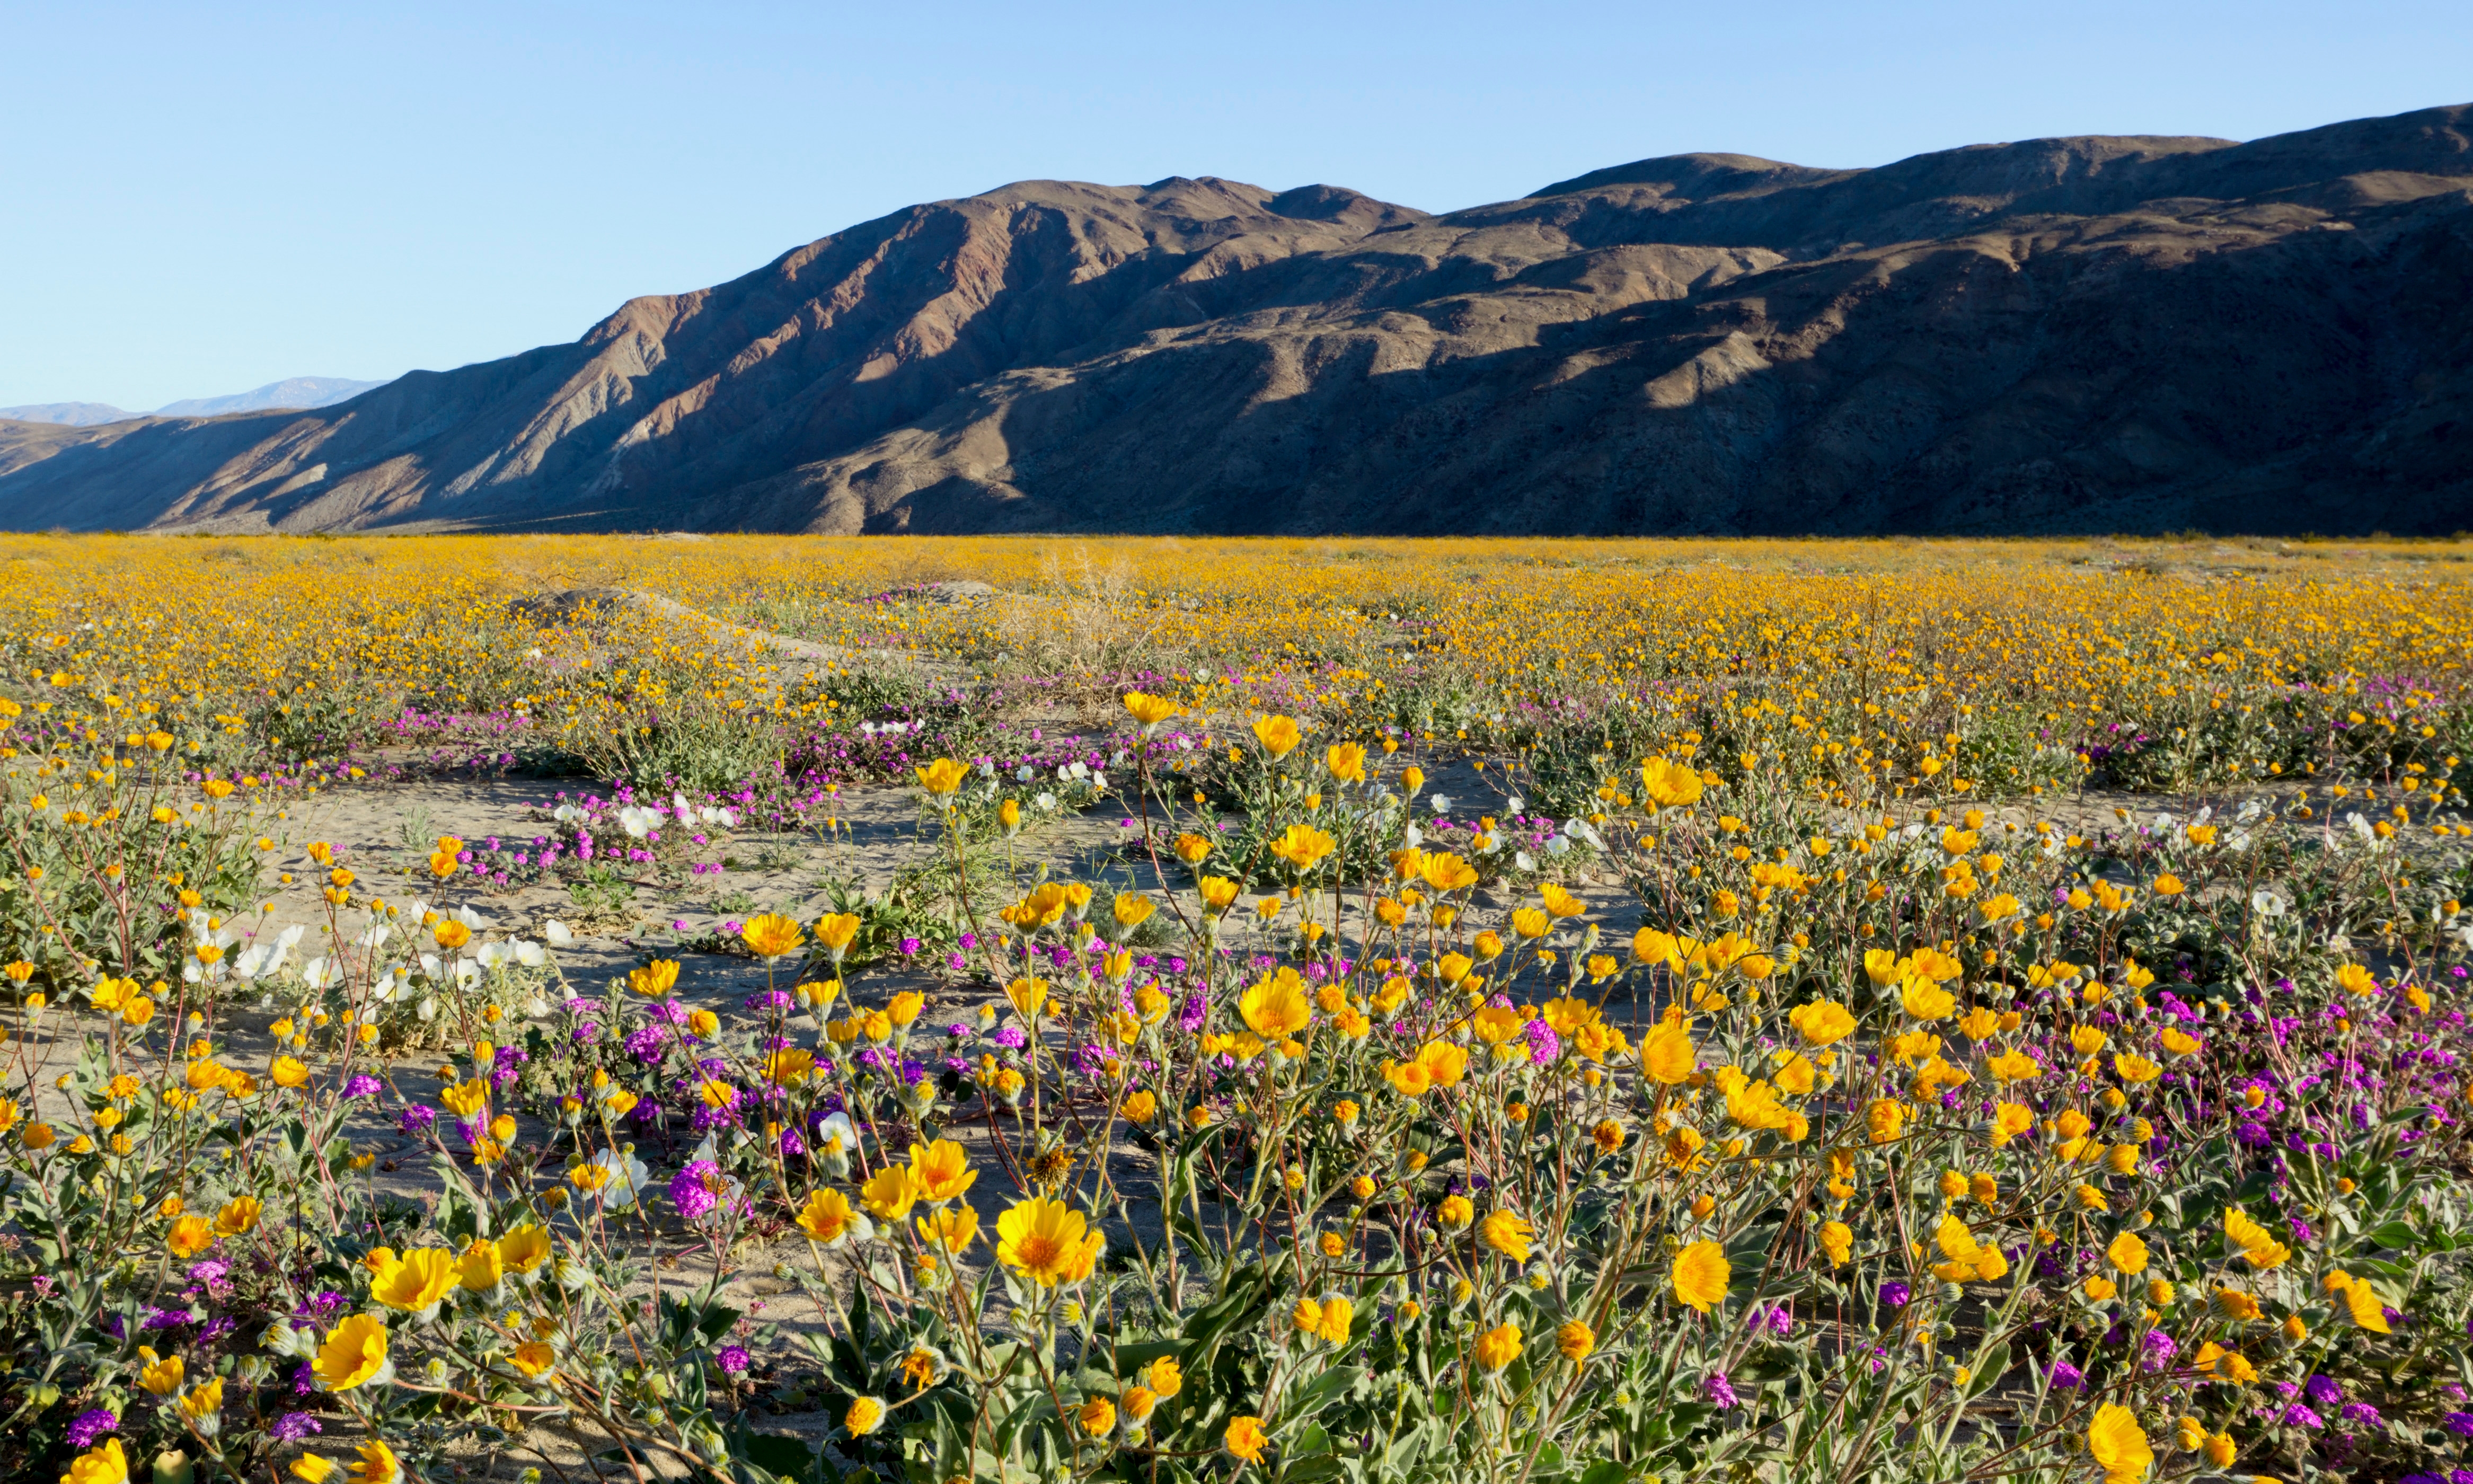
<box><xmin>0</xmin><ymin>537</ymin><xmax>2473</xmax><ymax>1484</ymax></box>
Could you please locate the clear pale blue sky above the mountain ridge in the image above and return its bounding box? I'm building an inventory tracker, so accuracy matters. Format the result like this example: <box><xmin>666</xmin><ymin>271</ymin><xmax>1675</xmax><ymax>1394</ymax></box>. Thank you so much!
<box><xmin>0</xmin><ymin>0</ymin><xmax>2473</xmax><ymax>408</ymax></box>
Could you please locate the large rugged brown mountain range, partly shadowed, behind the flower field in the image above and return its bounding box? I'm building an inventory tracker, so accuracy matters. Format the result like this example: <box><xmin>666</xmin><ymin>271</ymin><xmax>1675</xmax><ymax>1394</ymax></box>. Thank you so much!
<box><xmin>0</xmin><ymin>104</ymin><xmax>2473</xmax><ymax>534</ymax></box>
